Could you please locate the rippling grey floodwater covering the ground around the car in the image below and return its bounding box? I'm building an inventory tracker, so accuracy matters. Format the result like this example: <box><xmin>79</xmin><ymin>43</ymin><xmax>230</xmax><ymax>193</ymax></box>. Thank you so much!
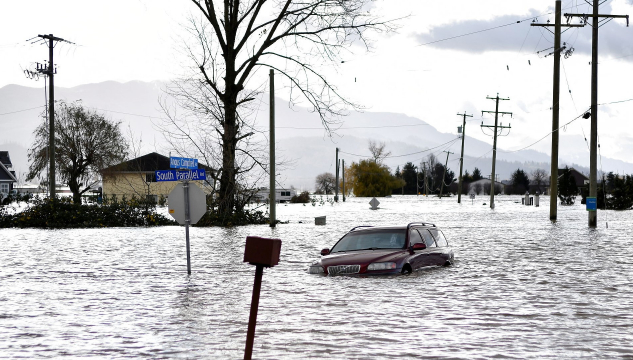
<box><xmin>0</xmin><ymin>196</ymin><xmax>633</xmax><ymax>359</ymax></box>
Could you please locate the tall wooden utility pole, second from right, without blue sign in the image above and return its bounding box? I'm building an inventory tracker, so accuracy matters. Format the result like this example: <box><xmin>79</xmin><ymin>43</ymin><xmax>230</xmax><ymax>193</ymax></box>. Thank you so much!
<box><xmin>531</xmin><ymin>0</ymin><xmax>585</xmax><ymax>221</ymax></box>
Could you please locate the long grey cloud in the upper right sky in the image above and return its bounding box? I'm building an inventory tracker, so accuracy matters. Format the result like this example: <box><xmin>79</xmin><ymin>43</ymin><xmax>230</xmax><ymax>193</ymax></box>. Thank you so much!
<box><xmin>414</xmin><ymin>4</ymin><xmax>633</xmax><ymax>61</ymax></box>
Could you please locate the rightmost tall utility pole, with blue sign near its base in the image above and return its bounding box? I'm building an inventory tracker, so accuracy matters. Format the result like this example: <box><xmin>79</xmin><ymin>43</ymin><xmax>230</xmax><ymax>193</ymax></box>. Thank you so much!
<box><xmin>564</xmin><ymin>0</ymin><xmax>629</xmax><ymax>228</ymax></box>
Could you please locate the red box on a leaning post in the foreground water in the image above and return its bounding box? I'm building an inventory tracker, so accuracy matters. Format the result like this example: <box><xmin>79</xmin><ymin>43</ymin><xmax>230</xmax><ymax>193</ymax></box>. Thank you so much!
<box><xmin>244</xmin><ymin>236</ymin><xmax>281</xmax><ymax>360</ymax></box>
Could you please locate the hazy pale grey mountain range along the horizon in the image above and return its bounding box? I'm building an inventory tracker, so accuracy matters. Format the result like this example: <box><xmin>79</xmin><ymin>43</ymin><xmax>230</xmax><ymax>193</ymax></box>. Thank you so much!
<box><xmin>0</xmin><ymin>81</ymin><xmax>633</xmax><ymax>190</ymax></box>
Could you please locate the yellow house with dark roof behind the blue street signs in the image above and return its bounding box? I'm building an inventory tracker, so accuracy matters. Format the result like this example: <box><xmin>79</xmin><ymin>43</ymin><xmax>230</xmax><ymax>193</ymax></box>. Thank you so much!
<box><xmin>101</xmin><ymin>152</ymin><xmax>213</xmax><ymax>201</ymax></box>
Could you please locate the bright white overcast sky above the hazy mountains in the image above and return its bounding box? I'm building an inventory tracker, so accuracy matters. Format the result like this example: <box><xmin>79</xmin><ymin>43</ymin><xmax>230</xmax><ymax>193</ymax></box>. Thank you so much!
<box><xmin>0</xmin><ymin>0</ymin><xmax>633</xmax><ymax>165</ymax></box>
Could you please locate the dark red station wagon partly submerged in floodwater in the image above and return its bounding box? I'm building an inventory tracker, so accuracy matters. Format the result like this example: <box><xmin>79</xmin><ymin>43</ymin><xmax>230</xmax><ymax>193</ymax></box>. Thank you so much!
<box><xmin>308</xmin><ymin>222</ymin><xmax>454</xmax><ymax>275</ymax></box>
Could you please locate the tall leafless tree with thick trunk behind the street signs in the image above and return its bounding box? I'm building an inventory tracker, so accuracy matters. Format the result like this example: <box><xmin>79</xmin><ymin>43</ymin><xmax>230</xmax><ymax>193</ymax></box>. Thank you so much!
<box><xmin>160</xmin><ymin>0</ymin><xmax>392</xmax><ymax>222</ymax></box>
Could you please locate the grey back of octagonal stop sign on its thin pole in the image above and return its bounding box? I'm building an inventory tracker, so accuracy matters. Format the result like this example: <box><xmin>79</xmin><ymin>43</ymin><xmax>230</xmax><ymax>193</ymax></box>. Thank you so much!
<box><xmin>168</xmin><ymin>180</ymin><xmax>207</xmax><ymax>274</ymax></box>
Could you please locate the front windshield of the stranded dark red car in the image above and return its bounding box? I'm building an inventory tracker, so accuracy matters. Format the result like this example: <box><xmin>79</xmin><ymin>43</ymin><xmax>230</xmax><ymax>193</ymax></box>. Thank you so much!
<box><xmin>331</xmin><ymin>229</ymin><xmax>406</xmax><ymax>253</ymax></box>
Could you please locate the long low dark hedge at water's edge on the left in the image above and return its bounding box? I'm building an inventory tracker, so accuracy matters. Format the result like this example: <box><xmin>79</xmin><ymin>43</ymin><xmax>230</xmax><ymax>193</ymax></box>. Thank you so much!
<box><xmin>0</xmin><ymin>197</ymin><xmax>176</xmax><ymax>229</ymax></box>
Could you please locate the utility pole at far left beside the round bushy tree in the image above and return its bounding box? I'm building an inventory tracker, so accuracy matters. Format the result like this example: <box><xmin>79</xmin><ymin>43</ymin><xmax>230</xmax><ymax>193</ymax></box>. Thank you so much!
<box><xmin>27</xmin><ymin>34</ymin><xmax>73</xmax><ymax>198</ymax></box>
